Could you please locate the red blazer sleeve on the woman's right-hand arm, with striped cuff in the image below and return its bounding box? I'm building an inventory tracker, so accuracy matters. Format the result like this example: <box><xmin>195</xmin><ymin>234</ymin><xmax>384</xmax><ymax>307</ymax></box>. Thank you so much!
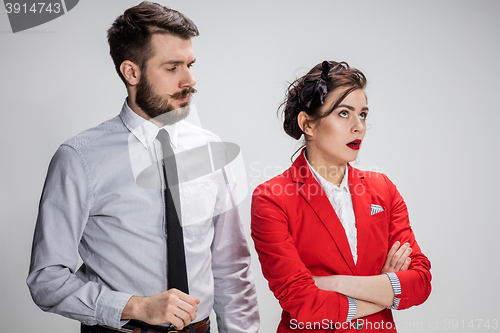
<box><xmin>384</xmin><ymin>175</ymin><xmax>432</xmax><ymax>310</ymax></box>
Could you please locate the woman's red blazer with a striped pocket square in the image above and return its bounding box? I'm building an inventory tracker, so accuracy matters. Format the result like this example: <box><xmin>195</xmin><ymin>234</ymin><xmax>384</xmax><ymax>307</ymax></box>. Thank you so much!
<box><xmin>252</xmin><ymin>154</ymin><xmax>431</xmax><ymax>332</ymax></box>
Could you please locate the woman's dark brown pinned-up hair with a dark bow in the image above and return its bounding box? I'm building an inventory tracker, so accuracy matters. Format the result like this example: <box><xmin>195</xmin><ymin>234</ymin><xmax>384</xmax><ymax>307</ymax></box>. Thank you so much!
<box><xmin>278</xmin><ymin>61</ymin><xmax>366</xmax><ymax>140</ymax></box>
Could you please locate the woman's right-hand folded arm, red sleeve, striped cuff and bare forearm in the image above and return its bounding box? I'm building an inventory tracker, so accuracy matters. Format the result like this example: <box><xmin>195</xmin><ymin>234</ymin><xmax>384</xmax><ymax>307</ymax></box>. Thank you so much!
<box><xmin>315</xmin><ymin>171</ymin><xmax>431</xmax><ymax>310</ymax></box>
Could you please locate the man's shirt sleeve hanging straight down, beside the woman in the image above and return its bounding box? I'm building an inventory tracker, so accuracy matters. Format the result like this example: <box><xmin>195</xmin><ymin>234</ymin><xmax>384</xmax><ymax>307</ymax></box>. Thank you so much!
<box><xmin>211</xmin><ymin>166</ymin><xmax>260</xmax><ymax>333</ymax></box>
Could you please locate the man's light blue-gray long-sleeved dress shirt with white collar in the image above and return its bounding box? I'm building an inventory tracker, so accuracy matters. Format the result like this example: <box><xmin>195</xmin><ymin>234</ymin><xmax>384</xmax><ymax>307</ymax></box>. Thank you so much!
<box><xmin>27</xmin><ymin>102</ymin><xmax>259</xmax><ymax>332</ymax></box>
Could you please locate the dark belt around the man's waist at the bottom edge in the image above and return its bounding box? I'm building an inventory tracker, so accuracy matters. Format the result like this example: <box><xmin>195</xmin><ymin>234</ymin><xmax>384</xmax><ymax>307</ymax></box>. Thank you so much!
<box><xmin>82</xmin><ymin>317</ymin><xmax>210</xmax><ymax>333</ymax></box>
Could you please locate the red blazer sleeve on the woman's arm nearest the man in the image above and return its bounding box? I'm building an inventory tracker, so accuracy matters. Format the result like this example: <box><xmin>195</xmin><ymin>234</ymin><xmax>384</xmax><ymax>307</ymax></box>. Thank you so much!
<box><xmin>252</xmin><ymin>183</ymin><xmax>354</xmax><ymax>323</ymax></box>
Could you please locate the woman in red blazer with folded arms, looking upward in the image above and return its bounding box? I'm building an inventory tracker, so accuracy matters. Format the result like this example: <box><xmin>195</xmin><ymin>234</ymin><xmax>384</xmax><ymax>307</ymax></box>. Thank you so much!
<box><xmin>252</xmin><ymin>61</ymin><xmax>431</xmax><ymax>332</ymax></box>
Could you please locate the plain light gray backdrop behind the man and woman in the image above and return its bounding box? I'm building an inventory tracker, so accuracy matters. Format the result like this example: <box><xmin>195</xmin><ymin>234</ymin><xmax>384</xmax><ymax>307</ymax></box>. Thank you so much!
<box><xmin>0</xmin><ymin>0</ymin><xmax>500</xmax><ymax>333</ymax></box>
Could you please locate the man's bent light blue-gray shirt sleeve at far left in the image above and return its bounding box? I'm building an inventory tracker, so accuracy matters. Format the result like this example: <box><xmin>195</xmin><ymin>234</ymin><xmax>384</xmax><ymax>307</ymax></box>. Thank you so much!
<box><xmin>27</xmin><ymin>145</ymin><xmax>132</xmax><ymax>328</ymax></box>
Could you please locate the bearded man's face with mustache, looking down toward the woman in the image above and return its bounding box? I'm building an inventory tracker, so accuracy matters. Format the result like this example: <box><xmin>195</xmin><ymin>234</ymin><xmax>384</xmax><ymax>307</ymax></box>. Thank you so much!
<box><xmin>135</xmin><ymin>34</ymin><xmax>196</xmax><ymax>123</ymax></box>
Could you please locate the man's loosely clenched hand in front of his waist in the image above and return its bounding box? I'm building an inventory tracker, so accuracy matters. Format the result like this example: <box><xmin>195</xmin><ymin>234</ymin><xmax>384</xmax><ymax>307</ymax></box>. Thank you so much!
<box><xmin>122</xmin><ymin>289</ymin><xmax>200</xmax><ymax>330</ymax></box>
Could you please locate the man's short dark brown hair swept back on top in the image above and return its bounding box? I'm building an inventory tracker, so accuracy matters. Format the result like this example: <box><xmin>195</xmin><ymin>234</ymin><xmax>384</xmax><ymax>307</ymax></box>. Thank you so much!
<box><xmin>108</xmin><ymin>1</ymin><xmax>199</xmax><ymax>84</ymax></box>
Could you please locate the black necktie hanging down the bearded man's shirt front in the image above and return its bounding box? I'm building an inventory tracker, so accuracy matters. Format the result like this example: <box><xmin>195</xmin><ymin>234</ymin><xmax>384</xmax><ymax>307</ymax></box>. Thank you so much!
<box><xmin>156</xmin><ymin>129</ymin><xmax>189</xmax><ymax>294</ymax></box>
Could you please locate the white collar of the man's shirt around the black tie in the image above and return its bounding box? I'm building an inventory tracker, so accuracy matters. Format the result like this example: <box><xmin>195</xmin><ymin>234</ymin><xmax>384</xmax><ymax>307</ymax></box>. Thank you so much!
<box><xmin>120</xmin><ymin>99</ymin><xmax>179</xmax><ymax>149</ymax></box>
